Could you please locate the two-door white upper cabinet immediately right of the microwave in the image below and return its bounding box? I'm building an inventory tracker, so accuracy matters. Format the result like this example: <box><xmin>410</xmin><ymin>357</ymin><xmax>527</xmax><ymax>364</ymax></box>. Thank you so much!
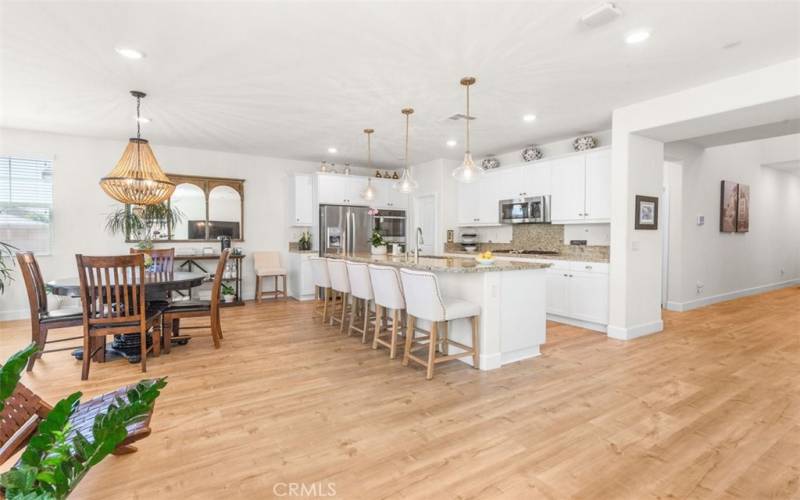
<box><xmin>550</xmin><ymin>149</ymin><xmax>611</xmax><ymax>224</ymax></box>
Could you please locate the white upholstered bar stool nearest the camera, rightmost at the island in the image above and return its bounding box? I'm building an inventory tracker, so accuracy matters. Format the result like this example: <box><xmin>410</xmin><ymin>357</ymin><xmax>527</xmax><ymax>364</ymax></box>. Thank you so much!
<box><xmin>400</xmin><ymin>269</ymin><xmax>481</xmax><ymax>380</ymax></box>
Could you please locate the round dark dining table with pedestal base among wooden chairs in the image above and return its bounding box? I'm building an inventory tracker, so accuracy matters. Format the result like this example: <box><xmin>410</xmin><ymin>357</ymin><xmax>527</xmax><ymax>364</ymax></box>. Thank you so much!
<box><xmin>47</xmin><ymin>271</ymin><xmax>208</xmax><ymax>363</ymax></box>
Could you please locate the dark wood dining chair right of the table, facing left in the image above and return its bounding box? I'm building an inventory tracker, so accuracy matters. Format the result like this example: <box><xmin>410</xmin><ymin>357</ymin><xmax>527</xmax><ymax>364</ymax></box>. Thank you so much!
<box><xmin>161</xmin><ymin>249</ymin><xmax>231</xmax><ymax>353</ymax></box>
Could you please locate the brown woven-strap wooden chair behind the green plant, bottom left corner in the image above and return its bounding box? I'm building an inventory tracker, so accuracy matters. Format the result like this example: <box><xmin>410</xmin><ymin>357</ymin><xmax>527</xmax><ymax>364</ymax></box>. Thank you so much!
<box><xmin>0</xmin><ymin>383</ymin><xmax>152</xmax><ymax>464</ymax></box>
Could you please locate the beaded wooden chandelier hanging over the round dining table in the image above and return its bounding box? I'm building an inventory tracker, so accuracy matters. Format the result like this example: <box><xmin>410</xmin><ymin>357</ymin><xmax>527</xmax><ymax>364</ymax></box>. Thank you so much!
<box><xmin>100</xmin><ymin>90</ymin><xmax>175</xmax><ymax>205</ymax></box>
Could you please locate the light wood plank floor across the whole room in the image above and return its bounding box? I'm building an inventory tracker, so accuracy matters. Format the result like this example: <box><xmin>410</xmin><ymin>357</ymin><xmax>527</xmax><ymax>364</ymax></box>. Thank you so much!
<box><xmin>0</xmin><ymin>288</ymin><xmax>800</xmax><ymax>499</ymax></box>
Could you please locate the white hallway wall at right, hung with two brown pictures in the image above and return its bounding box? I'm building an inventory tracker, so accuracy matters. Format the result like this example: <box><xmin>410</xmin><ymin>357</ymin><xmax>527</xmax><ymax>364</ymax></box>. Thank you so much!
<box><xmin>668</xmin><ymin>134</ymin><xmax>800</xmax><ymax>311</ymax></box>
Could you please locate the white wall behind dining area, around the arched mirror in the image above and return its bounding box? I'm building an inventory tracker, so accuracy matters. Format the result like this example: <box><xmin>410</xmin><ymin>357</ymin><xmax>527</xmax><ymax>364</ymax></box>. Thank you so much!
<box><xmin>0</xmin><ymin>129</ymin><xmax>319</xmax><ymax>319</ymax></box>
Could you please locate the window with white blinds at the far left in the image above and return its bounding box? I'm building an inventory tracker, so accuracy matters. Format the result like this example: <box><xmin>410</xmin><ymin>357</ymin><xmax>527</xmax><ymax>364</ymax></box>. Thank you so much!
<box><xmin>0</xmin><ymin>156</ymin><xmax>53</xmax><ymax>254</ymax></box>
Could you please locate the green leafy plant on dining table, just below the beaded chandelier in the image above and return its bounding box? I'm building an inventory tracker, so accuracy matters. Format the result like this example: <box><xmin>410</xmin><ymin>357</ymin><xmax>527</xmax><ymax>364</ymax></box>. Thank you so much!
<box><xmin>106</xmin><ymin>202</ymin><xmax>183</xmax><ymax>250</ymax></box>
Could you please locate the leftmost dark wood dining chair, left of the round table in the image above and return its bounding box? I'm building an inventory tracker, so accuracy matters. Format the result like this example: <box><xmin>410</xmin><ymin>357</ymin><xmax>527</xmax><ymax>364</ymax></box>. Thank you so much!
<box><xmin>17</xmin><ymin>252</ymin><xmax>83</xmax><ymax>371</ymax></box>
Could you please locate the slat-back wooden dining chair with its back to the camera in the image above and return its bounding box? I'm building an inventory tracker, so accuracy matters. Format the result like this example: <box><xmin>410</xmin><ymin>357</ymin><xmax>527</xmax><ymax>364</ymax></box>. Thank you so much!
<box><xmin>75</xmin><ymin>254</ymin><xmax>165</xmax><ymax>380</ymax></box>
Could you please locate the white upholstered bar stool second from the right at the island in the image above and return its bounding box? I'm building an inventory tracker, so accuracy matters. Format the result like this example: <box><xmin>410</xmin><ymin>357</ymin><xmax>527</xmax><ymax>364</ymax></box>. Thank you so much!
<box><xmin>369</xmin><ymin>264</ymin><xmax>406</xmax><ymax>359</ymax></box>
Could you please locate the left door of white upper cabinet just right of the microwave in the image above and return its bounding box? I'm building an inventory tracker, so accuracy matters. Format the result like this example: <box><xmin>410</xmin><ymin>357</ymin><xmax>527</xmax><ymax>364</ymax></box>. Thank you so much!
<box><xmin>550</xmin><ymin>155</ymin><xmax>586</xmax><ymax>224</ymax></box>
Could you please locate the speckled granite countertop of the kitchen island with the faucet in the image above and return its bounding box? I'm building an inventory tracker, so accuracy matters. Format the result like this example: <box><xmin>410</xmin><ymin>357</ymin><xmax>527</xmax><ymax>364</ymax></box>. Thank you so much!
<box><xmin>327</xmin><ymin>253</ymin><xmax>550</xmax><ymax>273</ymax></box>
